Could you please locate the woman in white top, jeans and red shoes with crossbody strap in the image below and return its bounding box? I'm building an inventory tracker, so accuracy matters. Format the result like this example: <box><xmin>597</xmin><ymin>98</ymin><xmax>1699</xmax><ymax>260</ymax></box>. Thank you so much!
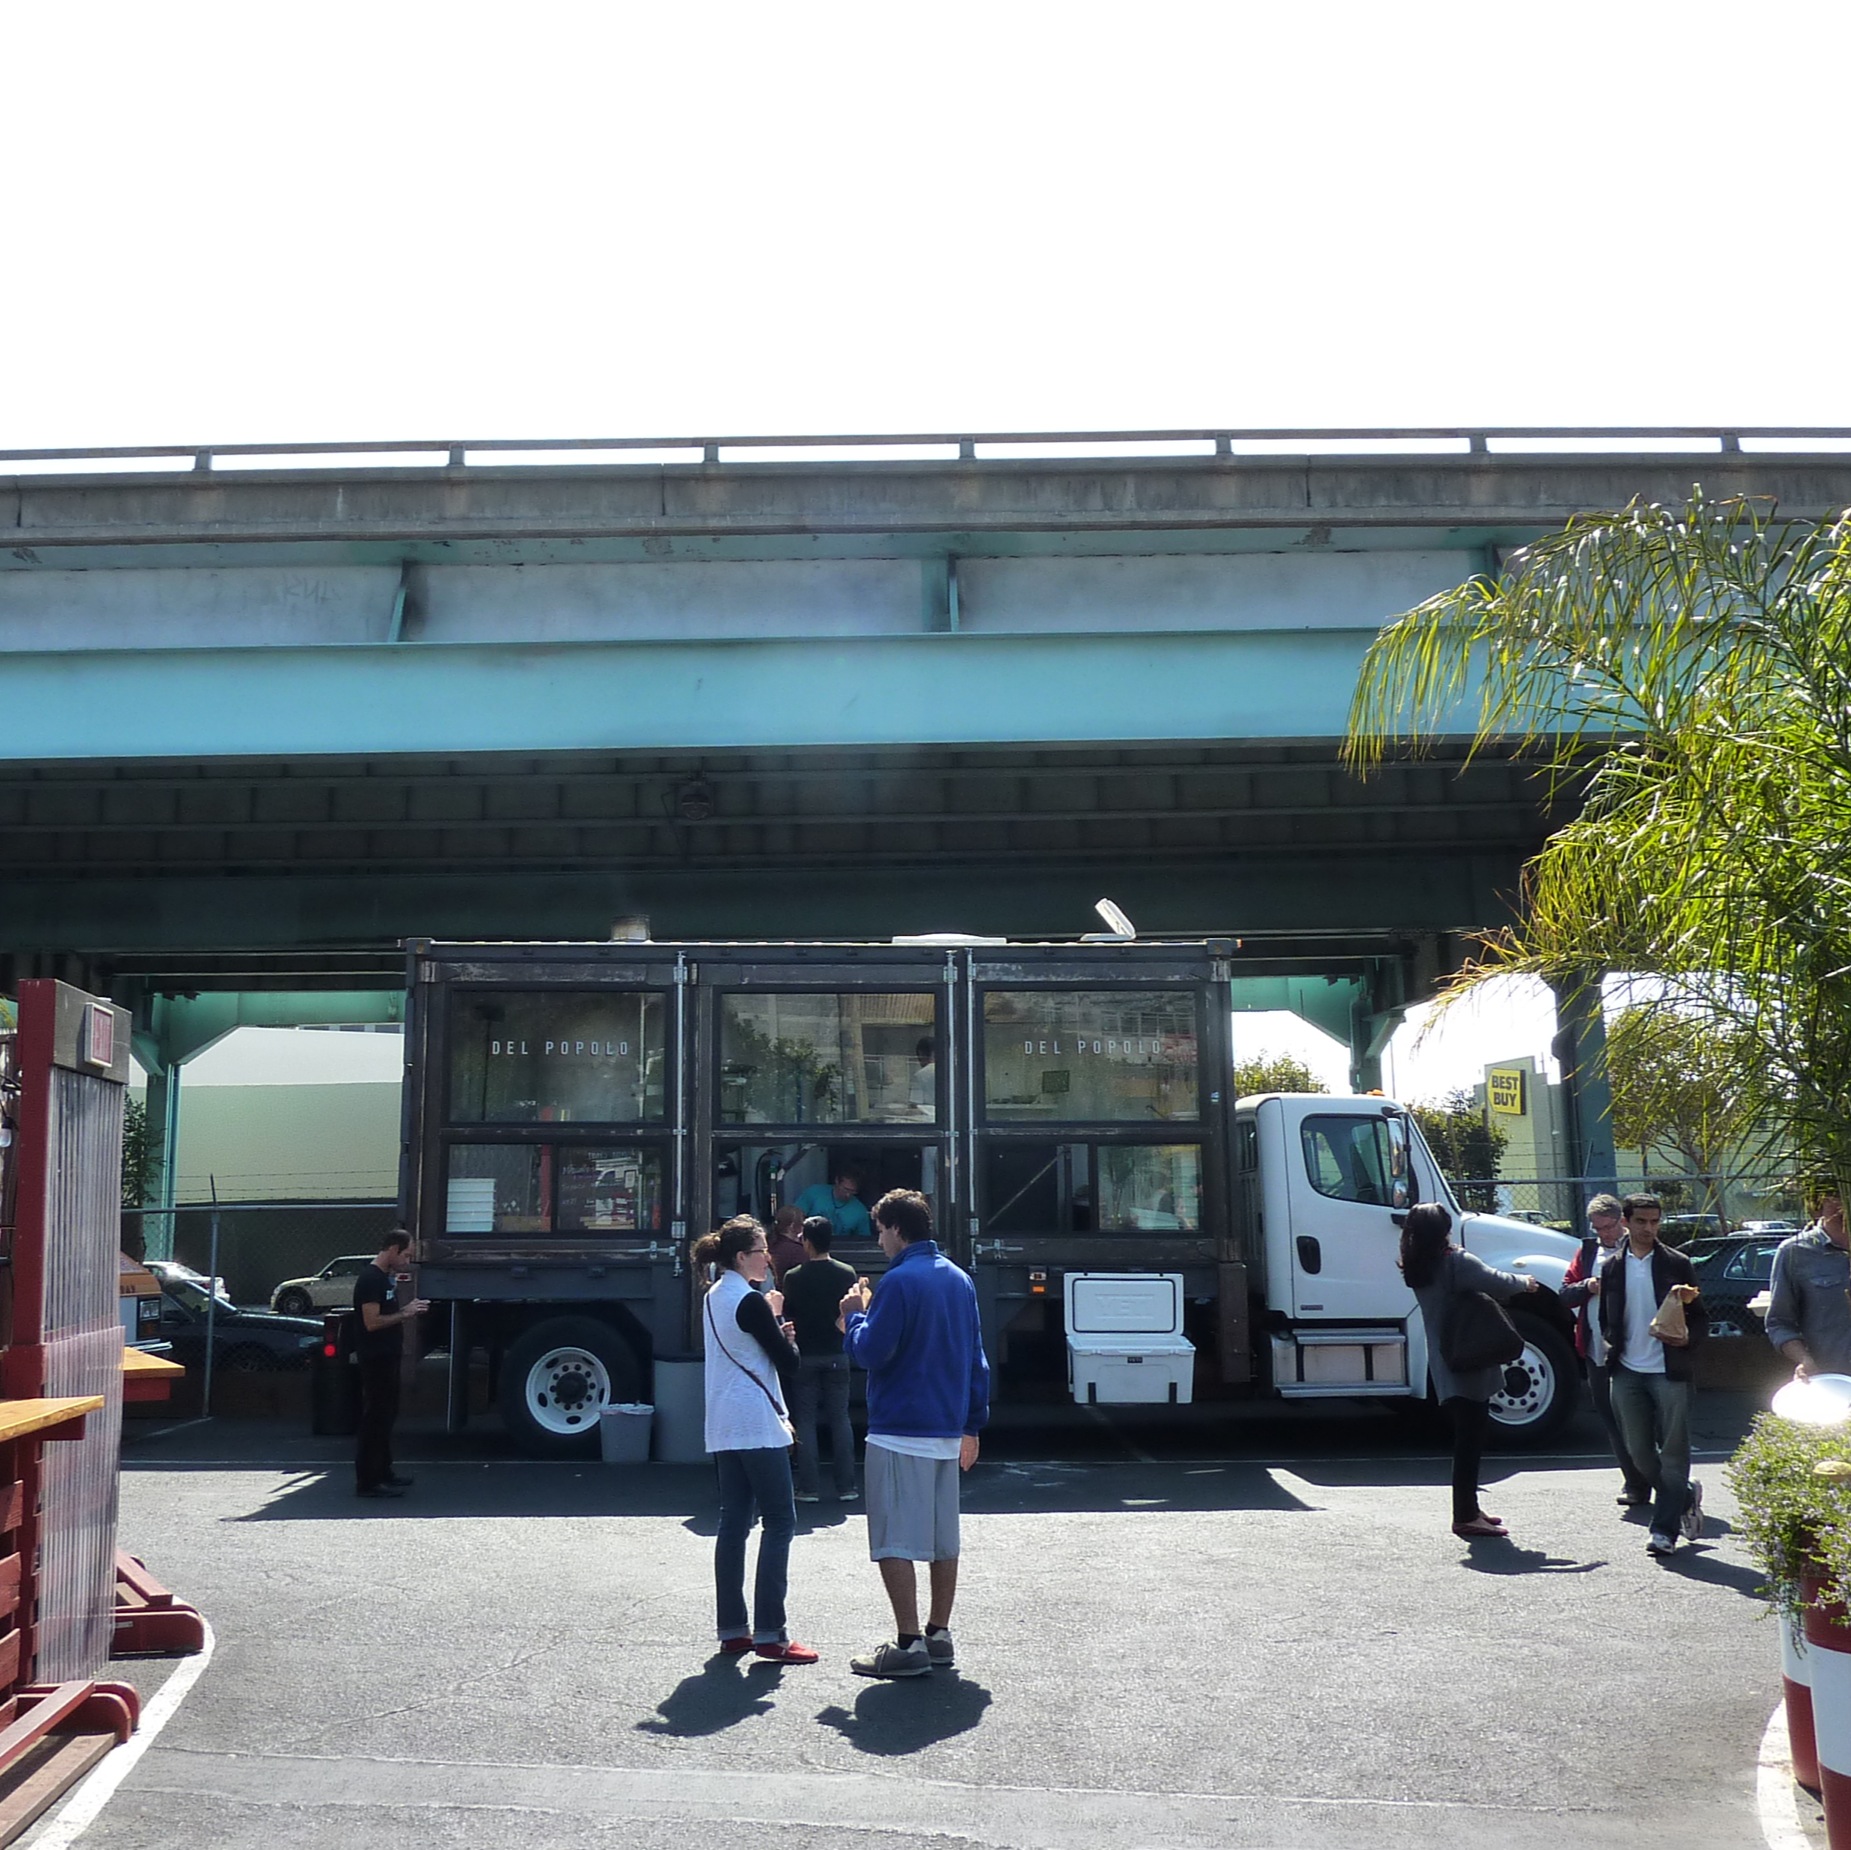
<box><xmin>694</xmin><ymin>1215</ymin><xmax>816</xmax><ymax>1663</ymax></box>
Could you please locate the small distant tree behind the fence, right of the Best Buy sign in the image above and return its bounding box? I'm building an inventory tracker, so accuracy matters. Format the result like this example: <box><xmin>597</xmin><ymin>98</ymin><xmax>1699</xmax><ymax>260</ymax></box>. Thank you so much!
<box><xmin>1607</xmin><ymin>1007</ymin><xmax>1770</xmax><ymax>1213</ymax></box>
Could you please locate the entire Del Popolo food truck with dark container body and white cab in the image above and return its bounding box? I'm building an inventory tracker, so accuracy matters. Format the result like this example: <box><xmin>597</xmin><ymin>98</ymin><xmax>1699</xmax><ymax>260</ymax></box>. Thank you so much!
<box><xmin>402</xmin><ymin>939</ymin><xmax>1579</xmax><ymax>1456</ymax></box>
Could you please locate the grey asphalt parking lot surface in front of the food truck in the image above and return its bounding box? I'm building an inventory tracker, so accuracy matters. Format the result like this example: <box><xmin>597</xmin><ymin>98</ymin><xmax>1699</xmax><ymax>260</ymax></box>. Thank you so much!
<box><xmin>46</xmin><ymin>1396</ymin><xmax>1806</xmax><ymax>1850</ymax></box>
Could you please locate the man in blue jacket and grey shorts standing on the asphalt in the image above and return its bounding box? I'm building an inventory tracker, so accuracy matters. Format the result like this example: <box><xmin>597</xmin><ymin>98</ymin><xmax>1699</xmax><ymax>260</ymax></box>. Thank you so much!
<box><xmin>842</xmin><ymin>1189</ymin><xmax>990</xmax><ymax>1676</ymax></box>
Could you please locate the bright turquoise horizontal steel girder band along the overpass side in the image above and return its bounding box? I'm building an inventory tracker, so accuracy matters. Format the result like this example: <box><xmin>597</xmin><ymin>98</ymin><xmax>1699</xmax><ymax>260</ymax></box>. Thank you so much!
<box><xmin>0</xmin><ymin>630</ymin><xmax>1465</xmax><ymax>761</ymax></box>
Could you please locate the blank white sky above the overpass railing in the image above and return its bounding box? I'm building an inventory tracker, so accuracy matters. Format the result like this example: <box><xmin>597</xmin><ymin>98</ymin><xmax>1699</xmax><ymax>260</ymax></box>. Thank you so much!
<box><xmin>0</xmin><ymin>0</ymin><xmax>1851</xmax><ymax>446</ymax></box>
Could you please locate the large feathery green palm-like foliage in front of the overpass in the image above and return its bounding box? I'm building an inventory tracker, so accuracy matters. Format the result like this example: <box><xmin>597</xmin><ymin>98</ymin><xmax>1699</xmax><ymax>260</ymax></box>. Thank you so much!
<box><xmin>1349</xmin><ymin>494</ymin><xmax>1851</xmax><ymax>1180</ymax></box>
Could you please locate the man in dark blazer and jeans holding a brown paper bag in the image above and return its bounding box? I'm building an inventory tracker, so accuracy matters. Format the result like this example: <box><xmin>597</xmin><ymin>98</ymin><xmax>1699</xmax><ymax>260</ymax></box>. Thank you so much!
<box><xmin>1599</xmin><ymin>1194</ymin><xmax>1708</xmax><ymax>1557</ymax></box>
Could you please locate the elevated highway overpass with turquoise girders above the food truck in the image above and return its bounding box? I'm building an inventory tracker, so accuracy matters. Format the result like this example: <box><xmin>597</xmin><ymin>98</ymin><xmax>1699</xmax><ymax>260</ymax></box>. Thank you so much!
<box><xmin>0</xmin><ymin>430</ymin><xmax>1851</xmax><ymax>1200</ymax></box>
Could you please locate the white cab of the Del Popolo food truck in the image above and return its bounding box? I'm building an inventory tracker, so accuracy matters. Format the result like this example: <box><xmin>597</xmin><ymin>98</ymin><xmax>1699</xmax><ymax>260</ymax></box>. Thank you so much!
<box><xmin>1235</xmin><ymin>1093</ymin><xmax>1579</xmax><ymax>1443</ymax></box>
